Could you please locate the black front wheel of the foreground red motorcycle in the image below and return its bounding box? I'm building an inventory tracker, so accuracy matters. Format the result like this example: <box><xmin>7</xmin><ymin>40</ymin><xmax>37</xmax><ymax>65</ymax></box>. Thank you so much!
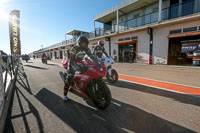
<box><xmin>92</xmin><ymin>82</ymin><xmax>111</xmax><ymax>109</ymax></box>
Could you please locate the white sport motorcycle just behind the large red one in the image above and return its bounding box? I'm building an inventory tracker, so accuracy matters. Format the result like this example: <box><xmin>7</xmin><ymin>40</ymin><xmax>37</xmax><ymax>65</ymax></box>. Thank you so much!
<box><xmin>99</xmin><ymin>56</ymin><xmax>119</xmax><ymax>83</ymax></box>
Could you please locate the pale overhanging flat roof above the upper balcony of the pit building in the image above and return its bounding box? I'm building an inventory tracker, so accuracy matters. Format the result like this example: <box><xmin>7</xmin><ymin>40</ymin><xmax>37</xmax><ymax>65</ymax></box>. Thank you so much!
<box><xmin>94</xmin><ymin>0</ymin><xmax>158</xmax><ymax>23</ymax></box>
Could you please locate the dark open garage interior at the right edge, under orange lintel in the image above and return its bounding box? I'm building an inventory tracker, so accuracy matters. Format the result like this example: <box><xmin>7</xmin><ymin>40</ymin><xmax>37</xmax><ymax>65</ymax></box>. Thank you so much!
<box><xmin>168</xmin><ymin>34</ymin><xmax>200</xmax><ymax>65</ymax></box>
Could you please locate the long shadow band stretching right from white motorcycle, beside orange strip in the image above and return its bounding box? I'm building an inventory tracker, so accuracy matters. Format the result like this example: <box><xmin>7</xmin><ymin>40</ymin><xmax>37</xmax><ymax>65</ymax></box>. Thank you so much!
<box><xmin>108</xmin><ymin>80</ymin><xmax>200</xmax><ymax>106</ymax></box>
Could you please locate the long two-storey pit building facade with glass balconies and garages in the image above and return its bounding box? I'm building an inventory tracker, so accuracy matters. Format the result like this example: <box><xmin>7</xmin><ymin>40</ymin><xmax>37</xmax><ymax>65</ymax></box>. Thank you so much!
<box><xmin>35</xmin><ymin>0</ymin><xmax>200</xmax><ymax>65</ymax></box>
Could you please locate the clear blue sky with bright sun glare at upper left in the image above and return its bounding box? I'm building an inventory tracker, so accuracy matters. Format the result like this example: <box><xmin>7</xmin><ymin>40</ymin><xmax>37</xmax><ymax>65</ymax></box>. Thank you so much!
<box><xmin>0</xmin><ymin>0</ymin><xmax>124</xmax><ymax>54</ymax></box>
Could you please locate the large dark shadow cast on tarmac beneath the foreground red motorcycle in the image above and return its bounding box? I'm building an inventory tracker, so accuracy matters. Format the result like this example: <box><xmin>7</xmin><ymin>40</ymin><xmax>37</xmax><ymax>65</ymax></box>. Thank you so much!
<box><xmin>35</xmin><ymin>88</ymin><xmax>193</xmax><ymax>133</ymax></box>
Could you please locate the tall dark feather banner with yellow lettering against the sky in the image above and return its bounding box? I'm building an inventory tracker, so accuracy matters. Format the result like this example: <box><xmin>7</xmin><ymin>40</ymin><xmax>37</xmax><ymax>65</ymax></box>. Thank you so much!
<box><xmin>9</xmin><ymin>10</ymin><xmax>21</xmax><ymax>55</ymax></box>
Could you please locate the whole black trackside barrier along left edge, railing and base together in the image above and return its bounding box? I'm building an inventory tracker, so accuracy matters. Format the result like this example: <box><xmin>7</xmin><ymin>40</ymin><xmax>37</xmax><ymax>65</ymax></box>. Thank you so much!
<box><xmin>0</xmin><ymin>54</ymin><xmax>19</xmax><ymax>132</ymax></box>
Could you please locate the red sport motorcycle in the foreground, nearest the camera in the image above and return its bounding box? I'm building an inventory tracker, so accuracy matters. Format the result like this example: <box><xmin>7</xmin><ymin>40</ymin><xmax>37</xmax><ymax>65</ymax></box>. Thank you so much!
<box><xmin>59</xmin><ymin>56</ymin><xmax>111</xmax><ymax>109</ymax></box>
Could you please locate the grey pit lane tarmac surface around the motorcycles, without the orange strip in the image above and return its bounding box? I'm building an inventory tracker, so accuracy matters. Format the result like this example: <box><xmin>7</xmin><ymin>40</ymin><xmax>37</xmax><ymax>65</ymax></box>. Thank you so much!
<box><xmin>5</xmin><ymin>60</ymin><xmax>200</xmax><ymax>133</ymax></box>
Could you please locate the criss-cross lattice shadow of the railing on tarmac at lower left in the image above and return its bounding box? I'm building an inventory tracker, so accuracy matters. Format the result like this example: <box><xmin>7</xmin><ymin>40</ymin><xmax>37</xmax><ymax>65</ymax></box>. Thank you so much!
<box><xmin>4</xmin><ymin>63</ymin><xmax>44</xmax><ymax>133</ymax></box>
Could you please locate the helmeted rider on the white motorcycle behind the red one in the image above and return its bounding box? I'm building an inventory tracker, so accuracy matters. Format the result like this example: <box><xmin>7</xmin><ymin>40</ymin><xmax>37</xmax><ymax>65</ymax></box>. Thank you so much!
<box><xmin>93</xmin><ymin>40</ymin><xmax>108</xmax><ymax>58</ymax></box>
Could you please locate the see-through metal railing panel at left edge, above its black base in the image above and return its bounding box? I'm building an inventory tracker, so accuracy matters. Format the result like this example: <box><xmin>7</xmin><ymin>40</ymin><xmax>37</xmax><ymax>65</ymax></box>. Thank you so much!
<box><xmin>0</xmin><ymin>54</ymin><xmax>19</xmax><ymax>116</ymax></box>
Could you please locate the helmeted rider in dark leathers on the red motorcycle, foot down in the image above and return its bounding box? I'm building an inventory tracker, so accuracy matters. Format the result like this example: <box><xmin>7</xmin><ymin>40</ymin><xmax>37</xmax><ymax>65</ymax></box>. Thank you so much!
<box><xmin>64</xmin><ymin>36</ymin><xmax>92</xmax><ymax>100</ymax></box>
